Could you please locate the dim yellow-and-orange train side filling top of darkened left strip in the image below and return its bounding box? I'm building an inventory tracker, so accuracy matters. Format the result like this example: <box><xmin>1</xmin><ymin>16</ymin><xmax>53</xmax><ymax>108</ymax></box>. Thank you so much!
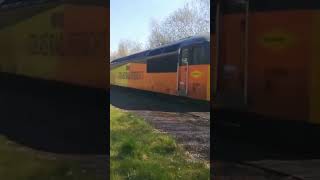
<box><xmin>0</xmin><ymin>3</ymin><xmax>109</xmax><ymax>88</ymax></box>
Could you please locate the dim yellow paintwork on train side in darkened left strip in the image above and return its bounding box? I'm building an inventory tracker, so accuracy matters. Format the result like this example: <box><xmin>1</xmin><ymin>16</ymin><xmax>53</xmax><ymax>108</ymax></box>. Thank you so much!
<box><xmin>0</xmin><ymin>6</ymin><xmax>63</xmax><ymax>79</ymax></box>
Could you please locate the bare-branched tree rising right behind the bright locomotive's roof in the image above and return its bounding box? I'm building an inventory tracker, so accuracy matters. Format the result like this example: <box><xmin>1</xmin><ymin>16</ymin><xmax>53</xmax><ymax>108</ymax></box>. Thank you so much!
<box><xmin>148</xmin><ymin>0</ymin><xmax>210</xmax><ymax>48</ymax></box>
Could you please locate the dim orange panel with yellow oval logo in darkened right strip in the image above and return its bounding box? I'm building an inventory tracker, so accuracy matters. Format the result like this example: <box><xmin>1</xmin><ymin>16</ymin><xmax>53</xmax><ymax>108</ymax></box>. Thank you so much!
<box><xmin>248</xmin><ymin>11</ymin><xmax>311</xmax><ymax>120</ymax></box>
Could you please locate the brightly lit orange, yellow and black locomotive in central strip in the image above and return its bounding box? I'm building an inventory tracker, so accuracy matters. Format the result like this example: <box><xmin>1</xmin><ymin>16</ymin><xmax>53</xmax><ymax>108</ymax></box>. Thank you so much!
<box><xmin>110</xmin><ymin>34</ymin><xmax>210</xmax><ymax>101</ymax></box>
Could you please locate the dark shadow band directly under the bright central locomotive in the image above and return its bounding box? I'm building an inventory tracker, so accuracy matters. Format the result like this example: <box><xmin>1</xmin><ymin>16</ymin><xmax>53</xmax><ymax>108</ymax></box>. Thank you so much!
<box><xmin>110</xmin><ymin>86</ymin><xmax>210</xmax><ymax>113</ymax></box>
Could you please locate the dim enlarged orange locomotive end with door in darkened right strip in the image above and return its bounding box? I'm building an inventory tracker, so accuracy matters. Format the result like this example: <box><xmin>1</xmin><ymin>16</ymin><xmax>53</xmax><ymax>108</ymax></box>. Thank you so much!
<box><xmin>212</xmin><ymin>0</ymin><xmax>320</xmax><ymax>125</ymax></box>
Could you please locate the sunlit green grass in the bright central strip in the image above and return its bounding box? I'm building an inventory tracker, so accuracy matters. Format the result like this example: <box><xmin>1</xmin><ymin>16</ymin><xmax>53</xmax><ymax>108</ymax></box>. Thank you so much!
<box><xmin>110</xmin><ymin>106</ymin><xmax>210</xmax><ymax>180</ymax></box>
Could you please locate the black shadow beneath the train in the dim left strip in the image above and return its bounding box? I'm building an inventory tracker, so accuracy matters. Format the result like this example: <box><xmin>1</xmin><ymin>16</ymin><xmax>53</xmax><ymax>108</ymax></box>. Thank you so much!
<box><xmin>0</xmin><ymin>75</ymin><xmax>109</xmax><ymax>154</ymax></box>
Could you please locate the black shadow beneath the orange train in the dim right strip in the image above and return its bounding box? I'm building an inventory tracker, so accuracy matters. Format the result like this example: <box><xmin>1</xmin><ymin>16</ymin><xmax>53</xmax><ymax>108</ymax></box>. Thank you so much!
<box><xmin>211</xmin><ymin>111</ymin><xmax>320</xmax><ymax>161</ymax></box>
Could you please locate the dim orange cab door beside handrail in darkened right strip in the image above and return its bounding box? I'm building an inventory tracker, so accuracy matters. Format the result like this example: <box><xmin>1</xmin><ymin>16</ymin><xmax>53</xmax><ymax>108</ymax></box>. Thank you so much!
<box><xmin>216</xmin><ymin>0</ymin><xmax>249</xmax><ymax>107</ymax></box>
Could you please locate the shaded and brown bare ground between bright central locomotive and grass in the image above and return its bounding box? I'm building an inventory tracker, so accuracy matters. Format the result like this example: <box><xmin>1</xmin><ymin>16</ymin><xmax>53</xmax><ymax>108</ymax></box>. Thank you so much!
<box><xmin>110</xmin><ymin>87</ymin><xmax>210</xmax><ymax>161</ymax></box>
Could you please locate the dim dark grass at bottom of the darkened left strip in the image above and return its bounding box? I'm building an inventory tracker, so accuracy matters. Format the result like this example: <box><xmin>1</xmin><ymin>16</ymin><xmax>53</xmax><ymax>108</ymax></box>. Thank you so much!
<box><xmin>0</xmin><ymin>136</ymin><xmax>102</xmax><ymax>180</ymax></box>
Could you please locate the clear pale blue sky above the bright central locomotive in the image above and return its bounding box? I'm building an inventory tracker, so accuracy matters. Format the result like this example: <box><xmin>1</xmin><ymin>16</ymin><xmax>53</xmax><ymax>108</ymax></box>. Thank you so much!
<box><xmin>110</xmin><ymin>0</ymin><xmax>187</xmax><ymax>51</ymax></box>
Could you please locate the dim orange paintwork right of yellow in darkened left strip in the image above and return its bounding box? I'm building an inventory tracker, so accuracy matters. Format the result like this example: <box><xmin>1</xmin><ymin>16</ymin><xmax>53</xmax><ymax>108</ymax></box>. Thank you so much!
<box><xmin>58</xmin><ymin>5</ymin><xmax>109</xmax><ymax>88</ymax></box>
